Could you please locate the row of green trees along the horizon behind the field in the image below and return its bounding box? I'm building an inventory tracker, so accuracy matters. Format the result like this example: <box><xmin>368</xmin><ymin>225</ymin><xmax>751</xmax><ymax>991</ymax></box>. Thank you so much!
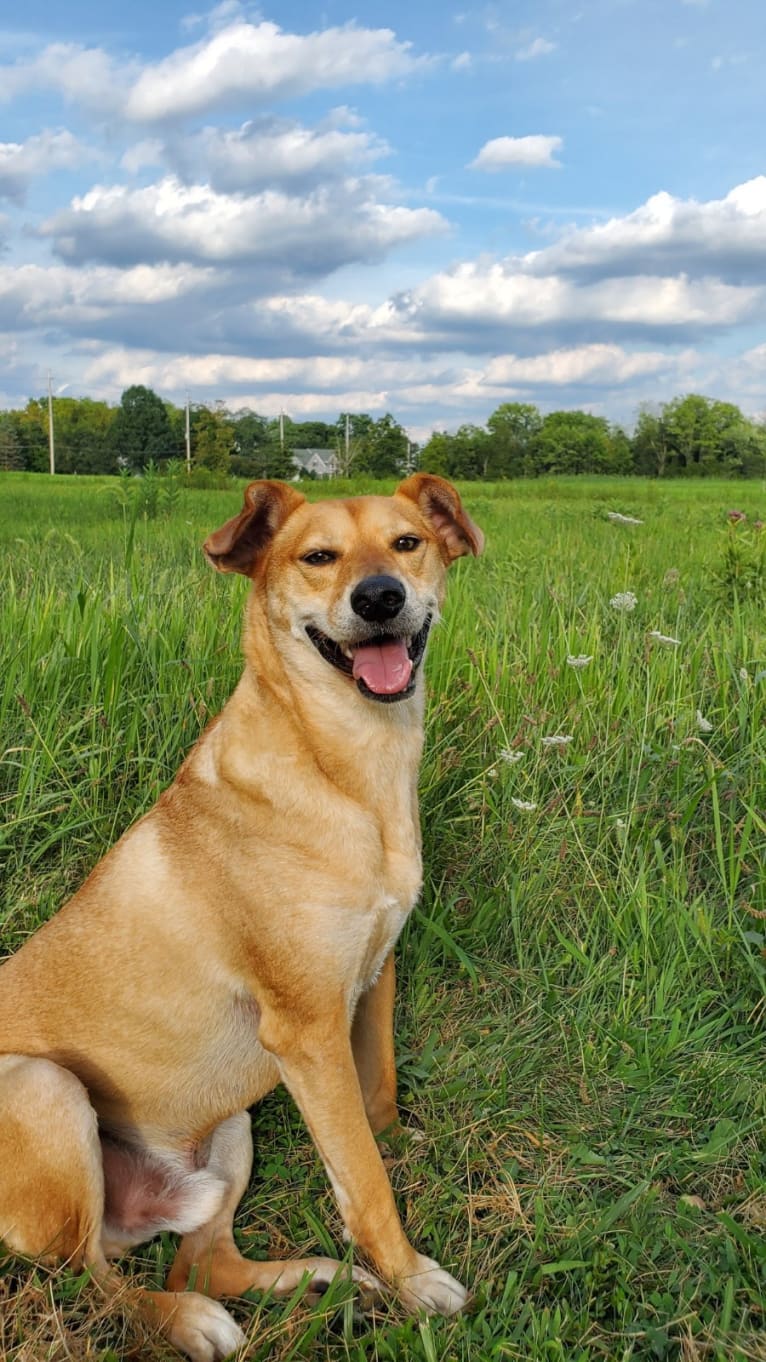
<box><xmin>0</xmin><ymin>384</ymin><xmax>766</xmax><ymax>481</ymax></box>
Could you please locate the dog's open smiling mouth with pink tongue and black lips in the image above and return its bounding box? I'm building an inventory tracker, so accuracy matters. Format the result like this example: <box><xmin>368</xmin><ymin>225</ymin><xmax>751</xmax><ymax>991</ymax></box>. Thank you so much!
<box><xmin>305</xmin><ymin>616</ymin><xmax>432</xmax><ymax>704</ymax></box>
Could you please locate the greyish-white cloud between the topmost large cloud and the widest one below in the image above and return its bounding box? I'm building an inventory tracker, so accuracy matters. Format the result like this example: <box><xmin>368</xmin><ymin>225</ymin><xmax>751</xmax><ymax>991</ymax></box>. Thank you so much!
<box><xmin>160</xmin><ymin>117</ymin><xmax>388</xmax><ymax>193</ymax></box>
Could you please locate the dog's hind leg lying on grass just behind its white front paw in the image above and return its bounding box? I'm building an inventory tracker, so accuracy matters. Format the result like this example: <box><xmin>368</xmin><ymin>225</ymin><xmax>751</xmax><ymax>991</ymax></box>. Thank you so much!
<box><xmin>166</xmin><ymin>1111</ymin><xmax>382</xmax><ymax>1297</ymax></box>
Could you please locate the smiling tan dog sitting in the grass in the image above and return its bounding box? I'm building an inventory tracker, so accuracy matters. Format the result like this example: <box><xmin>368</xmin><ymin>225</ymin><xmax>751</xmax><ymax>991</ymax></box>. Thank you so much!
<box><xmin>0</xmin><ymin>474</ymin><xmax>482</xmax><ymax>1362</ymax></box>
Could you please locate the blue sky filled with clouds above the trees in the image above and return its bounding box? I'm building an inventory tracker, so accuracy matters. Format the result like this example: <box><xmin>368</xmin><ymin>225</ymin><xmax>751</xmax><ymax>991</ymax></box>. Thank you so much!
<box><xmin>0</xmin><ymin>0</ymin><xmax>766</xmax><ymax>440</ymax></box>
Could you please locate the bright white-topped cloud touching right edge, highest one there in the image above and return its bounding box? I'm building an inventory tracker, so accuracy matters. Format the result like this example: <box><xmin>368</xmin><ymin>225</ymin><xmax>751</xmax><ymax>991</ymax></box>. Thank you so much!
<box><xmin>527</xmin><ymin>176</ymin><xmax>766</xmax><ymax>283</ymax></box>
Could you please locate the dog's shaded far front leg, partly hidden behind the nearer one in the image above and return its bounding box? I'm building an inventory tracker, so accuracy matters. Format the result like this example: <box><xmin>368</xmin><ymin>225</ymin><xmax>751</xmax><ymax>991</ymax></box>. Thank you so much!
<box><xmin>352</xmin><ymin>952</ymin><xmax>399</xmax><ymax>1135</ymax></box>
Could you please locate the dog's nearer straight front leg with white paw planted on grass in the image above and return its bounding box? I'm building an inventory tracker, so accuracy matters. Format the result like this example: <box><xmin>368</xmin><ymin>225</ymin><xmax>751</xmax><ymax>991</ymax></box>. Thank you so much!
<box><xmin>259</xmin><ymin>1007</ymin><xmax>468</xmax><ymax>1314</ymax></box>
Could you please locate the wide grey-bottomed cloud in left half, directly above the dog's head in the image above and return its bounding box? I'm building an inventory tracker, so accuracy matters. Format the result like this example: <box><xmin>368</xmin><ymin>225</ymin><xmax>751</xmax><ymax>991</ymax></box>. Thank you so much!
<box><xmin>41</xmin><ymin>176</ymin><xmax>446</xmax><ymax>278</ymax></box>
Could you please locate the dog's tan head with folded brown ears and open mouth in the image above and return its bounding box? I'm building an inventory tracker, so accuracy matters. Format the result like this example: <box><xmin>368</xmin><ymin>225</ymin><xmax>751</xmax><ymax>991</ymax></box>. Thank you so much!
<box><xmin>204</xmin><ymin>473</ymin><xmax>484</xmax><ymax>703</ymax></box>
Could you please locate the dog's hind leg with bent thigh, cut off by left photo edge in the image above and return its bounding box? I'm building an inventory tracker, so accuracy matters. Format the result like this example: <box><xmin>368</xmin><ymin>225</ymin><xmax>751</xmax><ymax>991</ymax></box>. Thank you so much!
<box><xmin>0</xmin><ymin>1054</ymin><xmax>244</xmax><ymax>1362</ymax></box>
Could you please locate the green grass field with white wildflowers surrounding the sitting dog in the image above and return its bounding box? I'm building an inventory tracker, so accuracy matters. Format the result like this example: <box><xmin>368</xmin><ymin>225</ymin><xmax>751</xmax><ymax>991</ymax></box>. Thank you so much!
<box><xmin>0</xmin><ymin>474</ymin><xmax>766</xmax><ymax>1362</ymax></box>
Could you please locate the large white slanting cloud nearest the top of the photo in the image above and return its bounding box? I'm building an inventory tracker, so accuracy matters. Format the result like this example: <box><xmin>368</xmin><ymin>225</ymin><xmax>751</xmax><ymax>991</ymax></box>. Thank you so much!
<box><xmin>124</xmin><ymin>20</ymin><xmax>424</xmax><ymax>123</ymax></box>
